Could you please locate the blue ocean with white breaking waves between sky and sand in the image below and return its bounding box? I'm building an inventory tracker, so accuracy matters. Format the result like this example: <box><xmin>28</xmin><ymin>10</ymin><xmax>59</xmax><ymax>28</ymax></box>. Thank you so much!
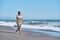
<box><xmin>0</xmin><ymin>20</ymin><xmax>60</xmax><ymax>37</ymax></box>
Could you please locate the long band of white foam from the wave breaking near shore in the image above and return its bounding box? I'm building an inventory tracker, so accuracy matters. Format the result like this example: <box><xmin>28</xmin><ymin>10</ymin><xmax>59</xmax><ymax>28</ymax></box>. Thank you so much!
<box><xmin>0</xmin><ymin>21</ymin><xmax>60</xmax><ymax>32</ymax></box>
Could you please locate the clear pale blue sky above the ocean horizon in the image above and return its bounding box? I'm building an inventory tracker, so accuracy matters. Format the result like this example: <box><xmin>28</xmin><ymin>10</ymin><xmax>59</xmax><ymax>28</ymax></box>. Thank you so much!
<box><xmin>0</xmin><ymin>0</ymin><xmax>60</xmax><ymax>19</ymax></box>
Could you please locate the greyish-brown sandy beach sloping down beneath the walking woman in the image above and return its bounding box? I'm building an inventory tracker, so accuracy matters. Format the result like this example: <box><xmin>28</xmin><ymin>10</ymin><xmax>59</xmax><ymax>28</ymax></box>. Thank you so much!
<box><xmin>0</xmin><ymin>26</ymin><xmax>60</xmax><ymax>40</ymax></box>
